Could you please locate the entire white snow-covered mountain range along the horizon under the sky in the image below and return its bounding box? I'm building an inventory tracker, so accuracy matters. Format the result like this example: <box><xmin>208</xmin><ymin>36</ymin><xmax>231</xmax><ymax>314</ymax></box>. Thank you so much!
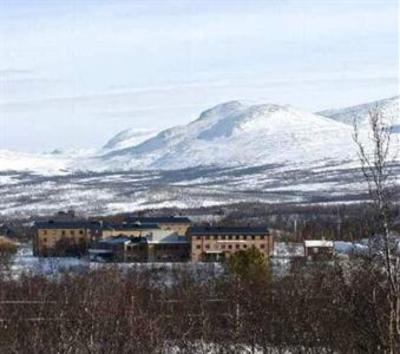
<box><xmin>0</xmin><ymin>96</ymin><xmax>400</xmax><ymax>175</ymax></box>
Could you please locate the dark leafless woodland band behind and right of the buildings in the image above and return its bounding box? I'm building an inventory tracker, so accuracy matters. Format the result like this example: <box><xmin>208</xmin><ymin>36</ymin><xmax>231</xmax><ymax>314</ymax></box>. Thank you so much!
<box><xmin>95</xmin><ymin>202</ymin><xmax>400</xmax><ymax>242</ymax></box>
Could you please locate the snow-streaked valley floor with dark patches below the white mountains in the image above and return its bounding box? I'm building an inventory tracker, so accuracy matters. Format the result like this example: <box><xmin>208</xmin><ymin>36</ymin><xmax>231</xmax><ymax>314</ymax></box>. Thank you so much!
<box><xmin>0</xmin><ymin>159</ymin><xmax>400</xmax><ymax>217</ymax></box>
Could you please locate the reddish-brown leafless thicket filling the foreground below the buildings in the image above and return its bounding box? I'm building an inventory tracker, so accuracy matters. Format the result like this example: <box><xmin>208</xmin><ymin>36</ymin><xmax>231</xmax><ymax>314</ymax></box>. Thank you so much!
<box><xmin>0</xmin><ymin>260</ymin><xmax>396</xmax><ymax>354</ymax></box>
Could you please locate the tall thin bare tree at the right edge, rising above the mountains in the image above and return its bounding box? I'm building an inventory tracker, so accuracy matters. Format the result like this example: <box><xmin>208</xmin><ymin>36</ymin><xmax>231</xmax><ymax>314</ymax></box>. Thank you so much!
<box><xmin>354</xmin><ymin>108</ymin><xmax>400</xmax><ymax>353</ymax></box>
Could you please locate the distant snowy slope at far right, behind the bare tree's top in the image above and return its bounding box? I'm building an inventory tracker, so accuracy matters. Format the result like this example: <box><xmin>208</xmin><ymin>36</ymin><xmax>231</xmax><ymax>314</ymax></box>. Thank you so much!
<box><xmin>318</xmin><ymin>96</ymin><xmax>400</xmax><ymax>133</ymax></box>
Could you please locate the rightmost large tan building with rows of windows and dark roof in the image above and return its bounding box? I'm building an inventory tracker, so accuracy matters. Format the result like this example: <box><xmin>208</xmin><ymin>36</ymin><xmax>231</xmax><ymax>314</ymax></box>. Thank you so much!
<box><xmin>188</xmin><ymin>226</ymin><xmax>274</xmax><ymax>262</ymax></box>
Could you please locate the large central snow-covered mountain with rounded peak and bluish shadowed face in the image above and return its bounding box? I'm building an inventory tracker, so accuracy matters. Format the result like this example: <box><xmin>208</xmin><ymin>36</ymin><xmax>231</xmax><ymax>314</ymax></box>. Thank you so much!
<box><xmin>95</xmin><ymin>101</ymin><xmax>354</xmax><ymax>170</ymax></box>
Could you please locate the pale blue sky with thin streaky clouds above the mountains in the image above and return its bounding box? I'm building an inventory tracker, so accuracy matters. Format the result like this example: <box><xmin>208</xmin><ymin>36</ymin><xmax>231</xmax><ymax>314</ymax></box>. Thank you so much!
<box><xmin>0</xmin><ymin>0</ymin><xmax>399</xmax><ymax>152</ymax></box>
